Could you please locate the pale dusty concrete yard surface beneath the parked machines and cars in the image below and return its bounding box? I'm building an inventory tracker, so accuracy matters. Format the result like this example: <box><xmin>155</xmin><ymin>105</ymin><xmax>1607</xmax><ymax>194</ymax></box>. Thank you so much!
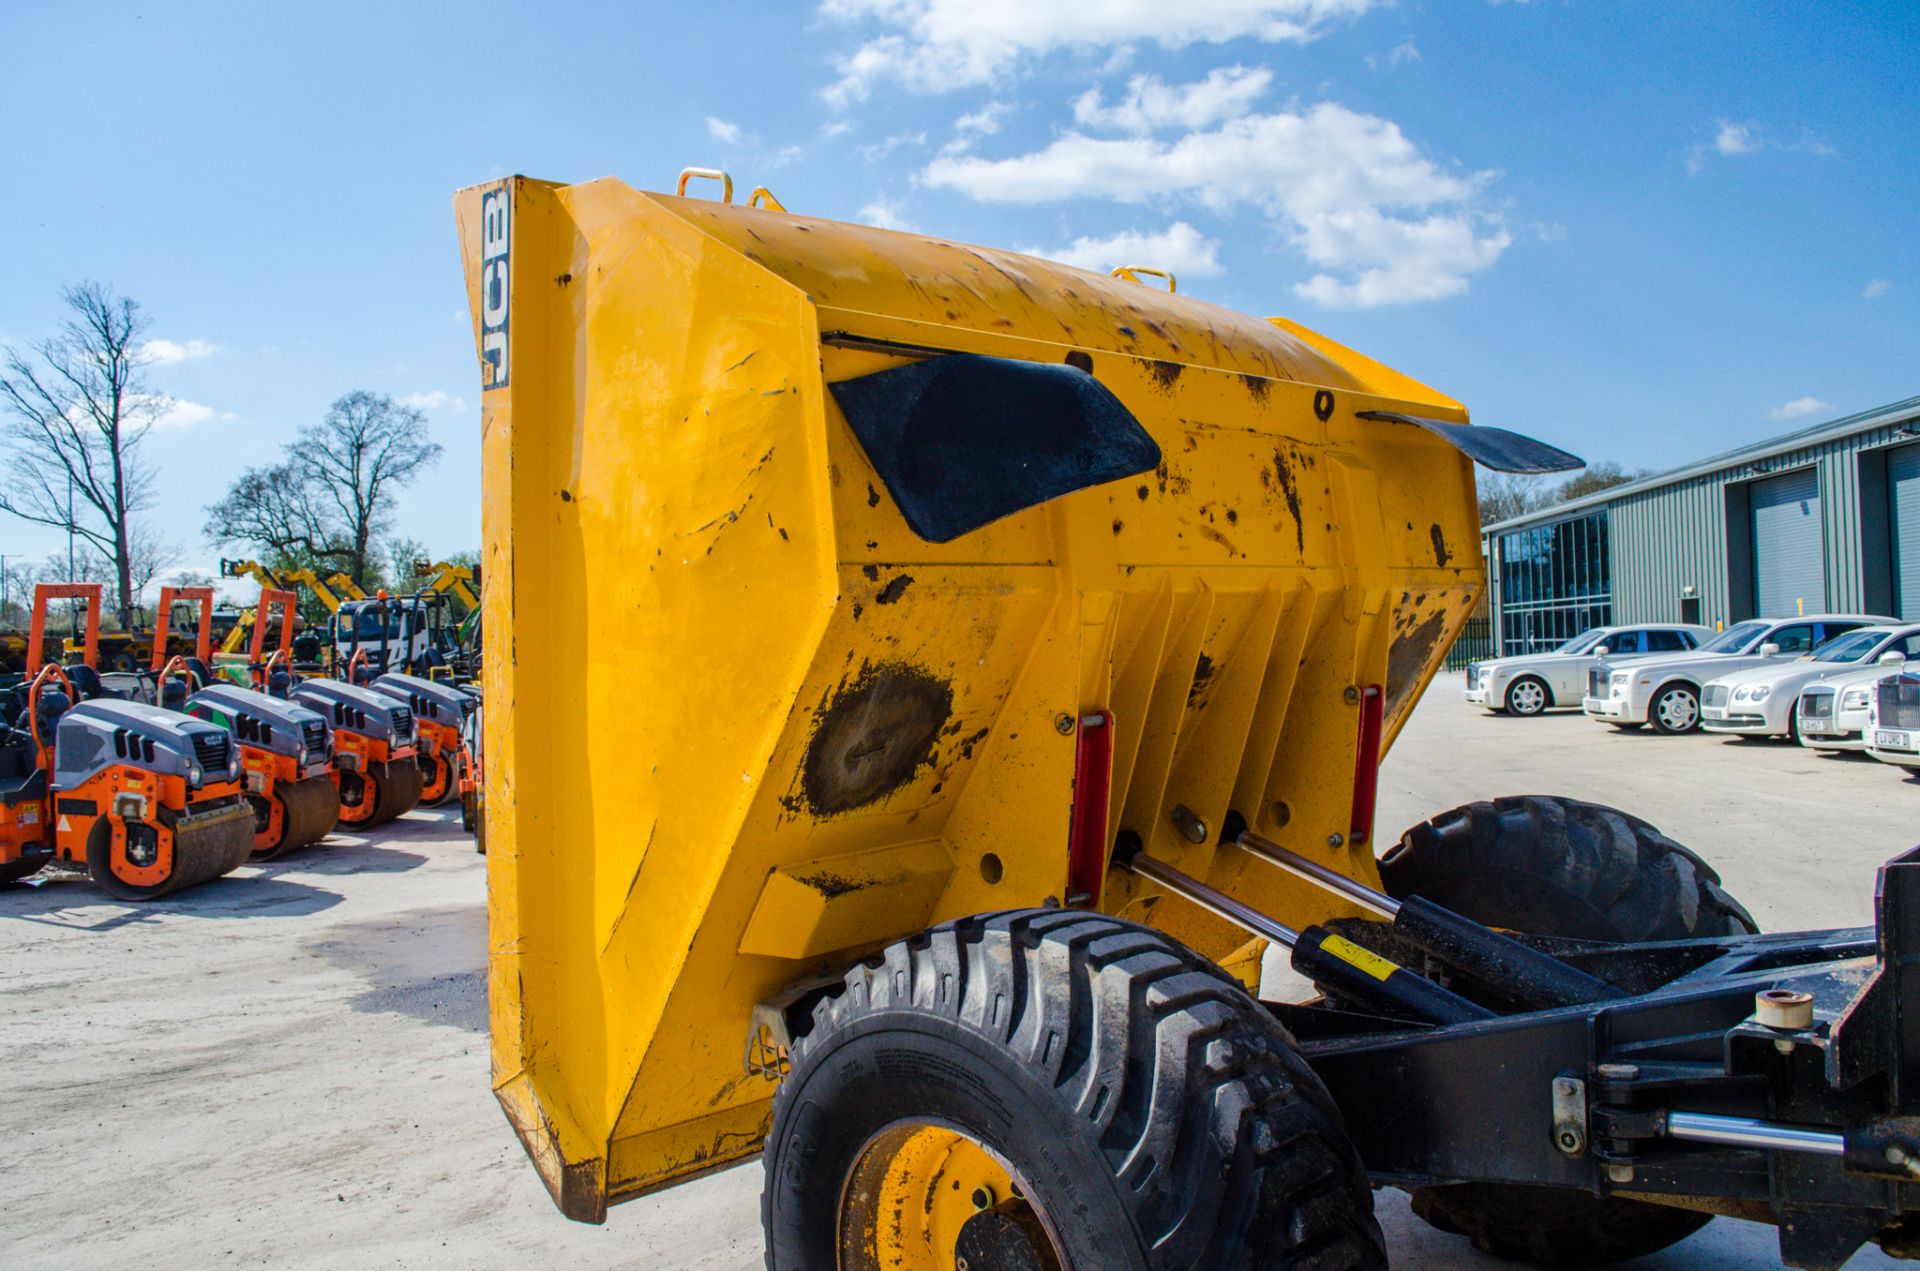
<box><xmin>0</xmin><ymin>676</ymin><xmax>1920</xmax><ymax>1269</ymax></box>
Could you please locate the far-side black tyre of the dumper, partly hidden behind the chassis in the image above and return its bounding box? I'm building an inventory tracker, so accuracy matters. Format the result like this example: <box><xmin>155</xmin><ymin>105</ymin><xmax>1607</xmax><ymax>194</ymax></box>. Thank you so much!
<box><xmin>1380</xmin><ymin>795</ymin><xmax>1759</xmax><ymax>1267</ymax></box>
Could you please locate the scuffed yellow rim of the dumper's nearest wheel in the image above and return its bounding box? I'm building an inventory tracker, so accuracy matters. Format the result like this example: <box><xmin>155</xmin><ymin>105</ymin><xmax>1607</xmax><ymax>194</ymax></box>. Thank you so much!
<box><xmin>839</xmin><ymin>1123</ymin><xmax>1066</xmax><ymax>1271</ymax></box>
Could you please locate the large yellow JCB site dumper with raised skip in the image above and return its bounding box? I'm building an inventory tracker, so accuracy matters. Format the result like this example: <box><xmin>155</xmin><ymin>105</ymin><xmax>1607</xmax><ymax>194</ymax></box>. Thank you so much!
<box><xmin>455</xmin><ymin>169</ymin><xmax>1920</xmax><ymax>1271</ymax></box>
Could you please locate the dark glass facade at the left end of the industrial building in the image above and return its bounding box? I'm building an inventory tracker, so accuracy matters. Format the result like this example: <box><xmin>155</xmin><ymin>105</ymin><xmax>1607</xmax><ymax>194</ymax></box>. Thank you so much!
<box><xmin>1498</xmin><ymin>509</ymin><xmax>1613</xmax><ymax>657</ymax></box>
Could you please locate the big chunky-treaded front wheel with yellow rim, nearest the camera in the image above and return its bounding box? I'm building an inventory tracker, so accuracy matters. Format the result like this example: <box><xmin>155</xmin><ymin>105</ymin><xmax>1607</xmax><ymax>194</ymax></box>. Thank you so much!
<box><xmin>760</xmin><ymin>908</ymin><xmax>1386</xmax><ymax>1271</ymax></box>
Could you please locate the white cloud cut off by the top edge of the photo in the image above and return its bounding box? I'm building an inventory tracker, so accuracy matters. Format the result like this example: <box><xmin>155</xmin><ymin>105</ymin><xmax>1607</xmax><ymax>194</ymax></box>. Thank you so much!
<box><xmin>820</xmin><ymin>0</ymin><xmax>1379</xmax><ymax>104</ymax></box>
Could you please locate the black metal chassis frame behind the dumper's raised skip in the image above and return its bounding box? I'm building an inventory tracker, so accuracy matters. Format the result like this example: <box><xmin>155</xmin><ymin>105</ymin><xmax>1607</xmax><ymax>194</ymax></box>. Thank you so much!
<box><xmin>1269</xmin><ymin>849</ymin><xmax>1920</xmax><ymax>1267</ymax></box>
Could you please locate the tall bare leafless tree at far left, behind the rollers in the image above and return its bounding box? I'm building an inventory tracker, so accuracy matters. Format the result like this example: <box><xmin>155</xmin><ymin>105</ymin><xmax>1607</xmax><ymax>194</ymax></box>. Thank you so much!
<box><xmin>0</xmin><ymin>282</ymin><xmax>167</xmax><ymax>624</ymax></box>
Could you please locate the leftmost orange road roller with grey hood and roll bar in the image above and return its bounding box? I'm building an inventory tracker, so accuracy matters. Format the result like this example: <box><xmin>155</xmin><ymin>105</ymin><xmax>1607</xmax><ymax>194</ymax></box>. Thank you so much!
<box><xmin>0</xmin><ymin>584</ymin><xmax>253</xmax><ymax>900</ymax></box>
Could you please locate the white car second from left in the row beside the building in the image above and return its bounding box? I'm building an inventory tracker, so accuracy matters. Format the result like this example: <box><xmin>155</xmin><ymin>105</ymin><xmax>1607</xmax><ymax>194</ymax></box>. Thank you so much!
<box><xmin>1580</xmin><ymin>614</ymin><xmax>1899</xmax><ymax>733</ymax></box>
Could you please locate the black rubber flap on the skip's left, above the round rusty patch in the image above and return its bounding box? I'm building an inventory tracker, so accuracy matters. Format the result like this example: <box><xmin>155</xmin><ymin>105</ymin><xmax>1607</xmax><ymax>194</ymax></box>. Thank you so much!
<box><xmin>829</xmin><ymin>353</ymin><xmax>1160</xmax><ymax>543</ymax></box>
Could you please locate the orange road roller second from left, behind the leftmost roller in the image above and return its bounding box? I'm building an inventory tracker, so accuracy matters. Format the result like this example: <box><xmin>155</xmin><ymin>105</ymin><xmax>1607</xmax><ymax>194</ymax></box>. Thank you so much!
<box><xmin>154</xmin><ymin>588</ymin><xmax>340</xmax><ymax>860</ymax></box>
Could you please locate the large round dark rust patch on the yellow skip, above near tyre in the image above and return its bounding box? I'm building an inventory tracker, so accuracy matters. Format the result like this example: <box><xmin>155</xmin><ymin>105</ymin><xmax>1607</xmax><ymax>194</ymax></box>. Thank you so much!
<box><xmin>801</xmin><ymin>662</ymin><xmax>954</xmax><ymax>816</ymax></box>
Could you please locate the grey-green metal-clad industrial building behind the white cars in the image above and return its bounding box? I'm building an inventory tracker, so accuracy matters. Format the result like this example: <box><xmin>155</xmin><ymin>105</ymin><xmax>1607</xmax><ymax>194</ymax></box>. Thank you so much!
<box><xmin>1482</xmin><ymin>397</ymin><xmax>1920</xmax><ymax>655</ymax></box>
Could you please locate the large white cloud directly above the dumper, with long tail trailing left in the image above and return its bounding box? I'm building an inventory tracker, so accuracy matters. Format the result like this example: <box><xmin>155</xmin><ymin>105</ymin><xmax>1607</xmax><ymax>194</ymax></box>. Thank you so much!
<box><xmin>922</xmin><ymin>102</ymin><xmax>1513</xmax><ymax>307</ymax></box>
